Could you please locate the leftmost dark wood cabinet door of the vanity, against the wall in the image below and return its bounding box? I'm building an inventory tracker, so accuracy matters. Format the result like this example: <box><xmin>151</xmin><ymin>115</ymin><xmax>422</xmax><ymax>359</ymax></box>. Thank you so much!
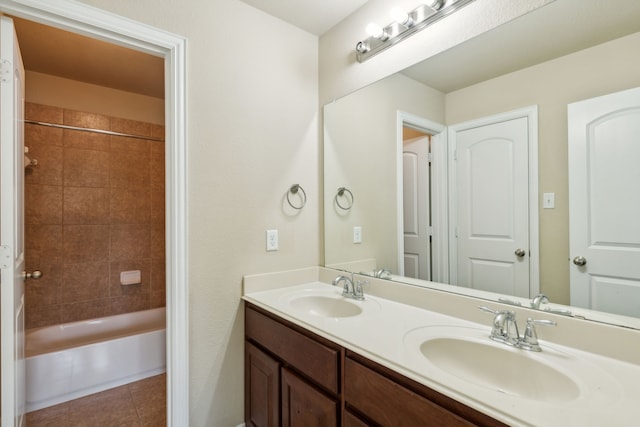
<box><xmin>244</xmin><ymin>342</ymin><xmax>280</xmax><ymax>427</ymax></box>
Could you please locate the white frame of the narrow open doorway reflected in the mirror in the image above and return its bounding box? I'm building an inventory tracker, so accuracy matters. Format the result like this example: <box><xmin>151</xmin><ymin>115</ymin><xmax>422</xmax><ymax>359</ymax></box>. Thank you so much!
<box><xmin>396</xmin><ymin>110</ymin><xmax>449</xmax><ymax>283</ymax></box>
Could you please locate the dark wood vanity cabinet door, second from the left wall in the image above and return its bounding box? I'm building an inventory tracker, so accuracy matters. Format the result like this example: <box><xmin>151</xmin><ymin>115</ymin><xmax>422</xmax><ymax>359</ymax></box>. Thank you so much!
<box><xmin>281</xmin><ymin>368</ymin><xmax>338</xmax><ymax>427</ymax></box>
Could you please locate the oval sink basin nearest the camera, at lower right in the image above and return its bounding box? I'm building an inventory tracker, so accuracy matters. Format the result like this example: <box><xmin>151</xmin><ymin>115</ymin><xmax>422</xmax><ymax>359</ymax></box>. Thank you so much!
<box><xmin>420</xmin><ymin>337</ymin><xmax>580</xmax><ymax>403</ymax></box>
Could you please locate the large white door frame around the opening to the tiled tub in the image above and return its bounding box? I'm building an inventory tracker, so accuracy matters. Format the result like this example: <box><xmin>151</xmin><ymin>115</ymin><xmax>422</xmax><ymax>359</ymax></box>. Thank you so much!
<box><xmin>0</xmin><ymin>0</ymin><xmax>189</xmax><ymax>426</ymax></box>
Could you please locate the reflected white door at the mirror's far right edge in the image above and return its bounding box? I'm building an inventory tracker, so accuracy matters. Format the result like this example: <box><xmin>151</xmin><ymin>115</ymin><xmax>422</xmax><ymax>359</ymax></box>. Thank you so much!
<box><xmin>568</xmin><ymin>88</ymin><xmax>640</xmax><ymax>317</ymax></box>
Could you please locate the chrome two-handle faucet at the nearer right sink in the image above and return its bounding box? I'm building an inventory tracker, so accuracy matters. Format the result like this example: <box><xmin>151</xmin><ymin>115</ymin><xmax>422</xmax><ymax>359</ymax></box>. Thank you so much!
<box><xmin>478</xmin><ymin>307</ymin><xmax>556</xmax><ymax>351</ymax></box>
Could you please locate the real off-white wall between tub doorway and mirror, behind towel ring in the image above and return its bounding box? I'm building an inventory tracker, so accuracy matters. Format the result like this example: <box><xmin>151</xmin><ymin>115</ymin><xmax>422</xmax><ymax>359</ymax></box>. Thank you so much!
<box><xmin>73</xmin><ymin>0</ymin><xmax>320</xmax><ymax>427</ymax></box>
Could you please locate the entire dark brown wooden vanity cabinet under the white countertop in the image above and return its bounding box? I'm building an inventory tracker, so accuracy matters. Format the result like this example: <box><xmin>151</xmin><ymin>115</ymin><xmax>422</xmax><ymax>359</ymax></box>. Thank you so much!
<box><xmin>245</xmin><ymin>303</ymin><xmax>506</xmax><ymax>427</ymax></box>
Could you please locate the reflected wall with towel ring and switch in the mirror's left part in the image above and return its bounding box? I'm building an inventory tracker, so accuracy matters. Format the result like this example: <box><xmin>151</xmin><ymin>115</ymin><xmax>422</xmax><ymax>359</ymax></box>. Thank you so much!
<box><xmin>324</xmin><ymin>74</ymin><xmax>445</xmax><ymax>272</ymax></box>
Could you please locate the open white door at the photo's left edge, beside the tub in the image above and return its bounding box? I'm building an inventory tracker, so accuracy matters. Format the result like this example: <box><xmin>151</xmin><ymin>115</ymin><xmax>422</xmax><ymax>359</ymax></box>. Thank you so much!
<box><xmin>0</xmin><ymin>16</ymin><xmax>25</xmax><ymax>427</ymax></box>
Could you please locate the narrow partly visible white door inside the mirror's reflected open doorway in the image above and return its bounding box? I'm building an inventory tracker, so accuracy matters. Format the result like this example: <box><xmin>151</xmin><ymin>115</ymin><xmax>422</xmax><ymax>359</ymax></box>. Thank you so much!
<box><xmin>402</xmin><ymin>136</ymin><xmax>431</xmax><ymax>280</ymax></box>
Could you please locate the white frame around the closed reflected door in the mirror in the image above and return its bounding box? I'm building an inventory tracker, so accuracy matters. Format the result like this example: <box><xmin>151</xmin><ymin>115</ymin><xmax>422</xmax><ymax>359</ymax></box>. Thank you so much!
<box><xmin>448</xmin><ymin>105</ymin><xmax>540</xmax><ymax>297</ymax></box>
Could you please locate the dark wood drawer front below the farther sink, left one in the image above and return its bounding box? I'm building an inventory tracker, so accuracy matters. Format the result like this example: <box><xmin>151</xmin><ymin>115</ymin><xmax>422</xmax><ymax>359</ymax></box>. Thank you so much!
<box><xmin>245</xmin><ymin>306</ymin><xmax>340</xmax><ymax>394</ymax></box>
